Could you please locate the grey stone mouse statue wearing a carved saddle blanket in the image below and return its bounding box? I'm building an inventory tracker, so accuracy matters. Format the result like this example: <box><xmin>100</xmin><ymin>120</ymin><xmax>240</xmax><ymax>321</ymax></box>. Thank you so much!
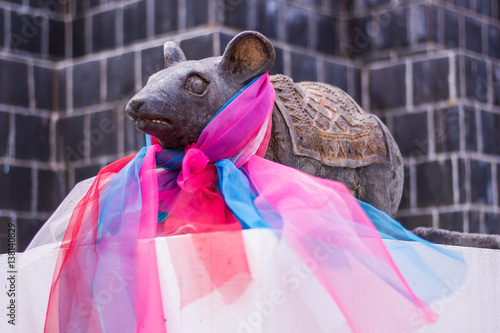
<box><xmin>126</xmin><ymin>31</ymin><xmax>403</xmax><ymax>216</ymax></box>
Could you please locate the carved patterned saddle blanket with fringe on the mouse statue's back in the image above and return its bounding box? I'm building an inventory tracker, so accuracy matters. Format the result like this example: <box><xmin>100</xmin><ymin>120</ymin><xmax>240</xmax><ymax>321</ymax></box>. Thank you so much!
<box><xmin>271</xmin><ymin>74</ymin><xmax>389</xmax><ymax>168</ymax></box>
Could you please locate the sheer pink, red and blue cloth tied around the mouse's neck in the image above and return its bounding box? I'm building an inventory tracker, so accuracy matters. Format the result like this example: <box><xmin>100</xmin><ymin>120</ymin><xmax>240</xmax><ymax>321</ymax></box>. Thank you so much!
<box><xmin>41</xmin><ymin>74</ymin><xmax>463</xmax><ymax>332</ymax></box>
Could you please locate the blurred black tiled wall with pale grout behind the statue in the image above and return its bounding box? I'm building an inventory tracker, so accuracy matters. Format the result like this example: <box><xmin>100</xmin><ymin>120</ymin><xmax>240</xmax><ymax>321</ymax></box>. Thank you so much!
<box><xmin>0</xmin><ymin>0</ymin><xmax>500</xmax><ymax>252</ymax></box>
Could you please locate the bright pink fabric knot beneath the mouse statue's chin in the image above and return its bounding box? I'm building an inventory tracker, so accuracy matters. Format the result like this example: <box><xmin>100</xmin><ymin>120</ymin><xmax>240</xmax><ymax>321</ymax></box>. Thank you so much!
<box><xmin>177</xmin><ymin>148</ymin><xmax>217</xmax><ymax>193</ymax></box>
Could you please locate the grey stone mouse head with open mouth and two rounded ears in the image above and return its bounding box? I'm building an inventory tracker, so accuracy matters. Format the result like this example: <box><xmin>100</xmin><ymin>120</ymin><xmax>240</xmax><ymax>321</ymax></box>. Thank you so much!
<box><xmin>126</xmin><ymin>31</ymin><xmax>276</xmax><ymax>149</ymax></box>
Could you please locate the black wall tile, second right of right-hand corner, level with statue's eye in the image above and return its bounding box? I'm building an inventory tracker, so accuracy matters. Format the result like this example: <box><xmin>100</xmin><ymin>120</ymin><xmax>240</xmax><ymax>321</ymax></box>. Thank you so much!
<box><xmin>413</xmin><ymin>58</ymin><xmax>450</xmax><ymax>105</ymax></box>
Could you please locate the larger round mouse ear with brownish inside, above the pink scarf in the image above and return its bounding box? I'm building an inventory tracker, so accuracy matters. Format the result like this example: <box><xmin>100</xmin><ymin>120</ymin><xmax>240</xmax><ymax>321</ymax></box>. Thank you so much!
<box><xmin>220</xmin><ymin>31</ymin><xmax>276</xmax><ymax>82</ymax></box>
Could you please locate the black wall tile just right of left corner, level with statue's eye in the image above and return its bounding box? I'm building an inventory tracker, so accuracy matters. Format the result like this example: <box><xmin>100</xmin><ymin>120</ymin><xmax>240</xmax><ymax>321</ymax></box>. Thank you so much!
<box><xmin>73</xmin><ymin>61</ymin><xmax>101</xmax><ymax>108</ymax></box>
